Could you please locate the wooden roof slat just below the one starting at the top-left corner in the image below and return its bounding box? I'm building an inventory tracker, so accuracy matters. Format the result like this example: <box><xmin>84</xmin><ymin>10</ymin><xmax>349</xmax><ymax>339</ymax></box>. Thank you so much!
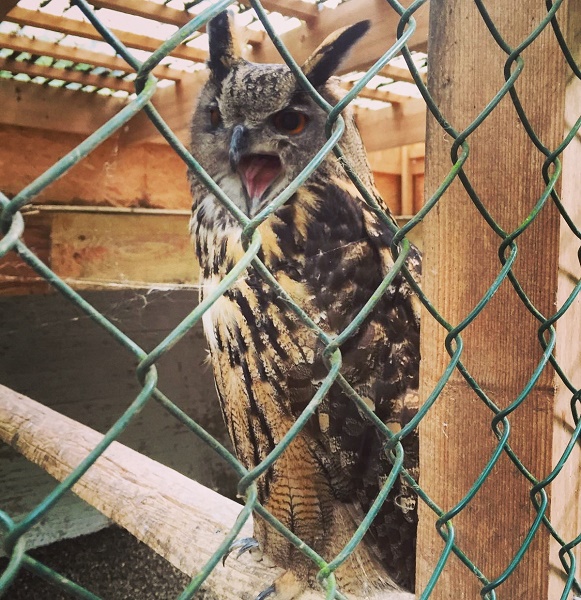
<box><xmin>0</xmin><ymin>34</ymin><xmax>184</xmax><ymax>81</ymax></box>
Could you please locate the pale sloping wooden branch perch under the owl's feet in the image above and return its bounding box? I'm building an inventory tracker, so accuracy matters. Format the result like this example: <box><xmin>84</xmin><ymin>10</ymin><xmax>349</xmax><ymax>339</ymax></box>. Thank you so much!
<box><xmin>0</xmin><ymin>385</ymin><xmax>413</xmax><ymax>600</ymax></box>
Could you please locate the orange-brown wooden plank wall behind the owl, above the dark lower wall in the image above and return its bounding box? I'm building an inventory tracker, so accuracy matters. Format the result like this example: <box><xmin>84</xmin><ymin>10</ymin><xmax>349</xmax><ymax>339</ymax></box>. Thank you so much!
<box><xmin>0</xmin><ymin>126</ymin><xmax>424</xmax><ymax>295</ymax></box>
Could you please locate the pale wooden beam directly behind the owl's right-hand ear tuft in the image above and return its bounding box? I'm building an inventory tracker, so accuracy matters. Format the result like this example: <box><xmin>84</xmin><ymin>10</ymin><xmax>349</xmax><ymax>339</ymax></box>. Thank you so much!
<box><xmin>247</xmin><ymin>0</ymin><xmax>428</xmax><ymax>73</ymax></box>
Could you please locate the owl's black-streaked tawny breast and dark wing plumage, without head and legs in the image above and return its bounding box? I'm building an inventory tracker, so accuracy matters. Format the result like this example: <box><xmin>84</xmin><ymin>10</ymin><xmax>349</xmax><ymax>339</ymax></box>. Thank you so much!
<box><xmin>192</xmin><ymin>173</ymin><xmax>420</xmax><ymax>587</ymax></box>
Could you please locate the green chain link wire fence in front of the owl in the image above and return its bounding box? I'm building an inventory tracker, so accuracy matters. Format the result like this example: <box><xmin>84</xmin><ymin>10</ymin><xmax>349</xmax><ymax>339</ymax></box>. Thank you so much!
<box><xmin>0</xmin><ymin>0</ymin><xmax>581</xmax><ymax>600</ymax></box>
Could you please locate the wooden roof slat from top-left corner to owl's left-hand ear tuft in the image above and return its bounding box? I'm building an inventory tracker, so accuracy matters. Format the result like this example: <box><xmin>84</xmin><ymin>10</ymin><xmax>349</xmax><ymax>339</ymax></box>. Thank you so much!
<box><xmin>6</xmin><ymin>6</ymin><xmax>208</xmax><ymax>62</ymax></box>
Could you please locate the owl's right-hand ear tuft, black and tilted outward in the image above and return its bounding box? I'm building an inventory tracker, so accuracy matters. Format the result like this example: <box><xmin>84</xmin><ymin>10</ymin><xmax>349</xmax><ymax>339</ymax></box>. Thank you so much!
<box><xmin>302</xmin><ymin>21</ymin><xmax>371</xmax><ymax>88</ymax></box>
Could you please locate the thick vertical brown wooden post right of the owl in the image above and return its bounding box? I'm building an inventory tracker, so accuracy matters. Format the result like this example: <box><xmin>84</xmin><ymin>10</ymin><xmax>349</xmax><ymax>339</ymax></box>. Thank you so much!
<box><xmin>417</xmin><ymin>0</ymin><xmax>580</xmax><ymax>600</ymax></box>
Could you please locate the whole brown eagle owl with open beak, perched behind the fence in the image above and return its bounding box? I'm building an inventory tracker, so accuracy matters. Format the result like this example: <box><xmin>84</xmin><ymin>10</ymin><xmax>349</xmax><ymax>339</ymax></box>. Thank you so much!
<box><xmin>190</xmin><ymin>13</ymin><xmax>420</xmax><ymax>600</ymax></box>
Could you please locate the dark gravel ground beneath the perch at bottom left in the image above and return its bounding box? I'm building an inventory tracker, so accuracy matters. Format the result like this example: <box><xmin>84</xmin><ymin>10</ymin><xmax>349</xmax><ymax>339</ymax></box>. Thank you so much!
<box><xmin>0</xmin><ymin>527</ymin><xmax>204</xmax><ymax>600</ymax></box>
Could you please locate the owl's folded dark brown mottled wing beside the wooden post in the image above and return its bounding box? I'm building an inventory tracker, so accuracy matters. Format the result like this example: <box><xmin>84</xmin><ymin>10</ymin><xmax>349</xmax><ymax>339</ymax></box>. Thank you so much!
<box><xmin>280</xmin><ymin>179</ymin><xmax>420</xmax><ymax>587</ymax></box>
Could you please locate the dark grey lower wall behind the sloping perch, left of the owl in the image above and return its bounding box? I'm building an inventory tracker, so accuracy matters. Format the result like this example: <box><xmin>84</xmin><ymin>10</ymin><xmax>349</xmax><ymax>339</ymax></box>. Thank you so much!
<box><xmin>0</xmin><ymin>290</ymin><xmax>235</xmax><ymax>547</ymax></box>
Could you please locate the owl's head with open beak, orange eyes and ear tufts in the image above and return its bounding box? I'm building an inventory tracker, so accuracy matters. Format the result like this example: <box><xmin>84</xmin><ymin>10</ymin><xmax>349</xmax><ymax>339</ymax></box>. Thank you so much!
<box><xmin>191</xmin><ymin>12</ymin><xmax>369</xmax><ymax>215</ymax></box>
